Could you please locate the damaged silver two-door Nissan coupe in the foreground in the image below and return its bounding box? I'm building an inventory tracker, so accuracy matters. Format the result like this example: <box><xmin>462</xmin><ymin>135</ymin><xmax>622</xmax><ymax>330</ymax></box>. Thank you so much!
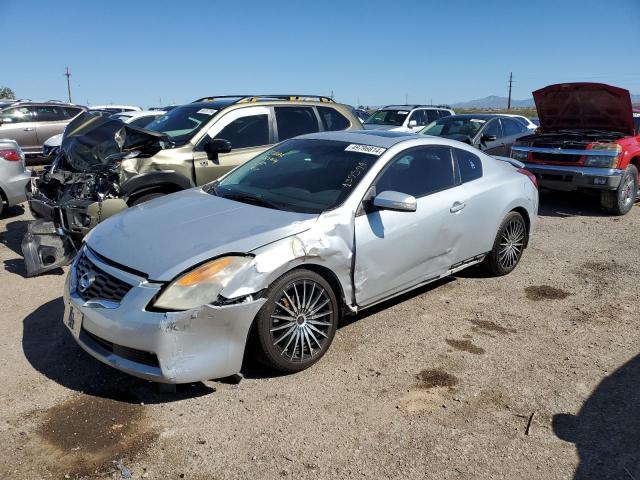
<box><xmin>64</xmin><ymin>131</ymin><xmax>538</xmax><ymax>383</ymax></box>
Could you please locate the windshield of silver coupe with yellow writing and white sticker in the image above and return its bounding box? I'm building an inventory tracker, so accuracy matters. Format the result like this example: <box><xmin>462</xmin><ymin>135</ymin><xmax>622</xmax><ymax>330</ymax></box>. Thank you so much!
<box><xmin>205</xmin><ymin>139</ymin><xmax>385</xmax><ymax>213</ymax></box>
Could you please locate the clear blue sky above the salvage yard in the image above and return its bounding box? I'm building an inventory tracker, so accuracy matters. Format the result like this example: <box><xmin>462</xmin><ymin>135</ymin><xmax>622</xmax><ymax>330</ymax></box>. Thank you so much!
<box><xmin>0</xmin><ymin>0</ymin><xmax>640</xmax><ymax>106</ymax></box>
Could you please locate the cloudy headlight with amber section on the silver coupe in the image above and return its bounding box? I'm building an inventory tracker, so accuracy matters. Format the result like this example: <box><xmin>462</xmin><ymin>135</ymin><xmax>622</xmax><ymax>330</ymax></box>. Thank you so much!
<box><xmin>153</xmin><ymin>256</ymin><xmax>251</xmax><ymax>310</ymax></box>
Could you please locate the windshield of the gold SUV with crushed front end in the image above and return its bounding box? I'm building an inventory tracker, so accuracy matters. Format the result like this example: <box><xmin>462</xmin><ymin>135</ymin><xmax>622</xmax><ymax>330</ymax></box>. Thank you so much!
<box><xmin>145</xmin><ymin>105</ymin><xmax>217</xmax><ymax>145</ymax></box>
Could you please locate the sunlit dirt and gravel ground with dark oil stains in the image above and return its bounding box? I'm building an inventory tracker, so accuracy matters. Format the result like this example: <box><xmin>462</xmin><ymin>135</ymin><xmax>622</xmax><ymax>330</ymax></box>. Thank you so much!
<box><xmin>0</xmin><ymin>189</ymin><xmax>640</xmax><ymax>480</ymax></box>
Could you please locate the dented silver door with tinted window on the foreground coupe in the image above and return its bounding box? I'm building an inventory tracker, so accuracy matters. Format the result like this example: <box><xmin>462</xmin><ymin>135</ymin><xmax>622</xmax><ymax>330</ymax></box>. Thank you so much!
<box><xmin>354</xmin><ymin>145</ymin><xmax>464</xmax><ymax>306</ymax></box>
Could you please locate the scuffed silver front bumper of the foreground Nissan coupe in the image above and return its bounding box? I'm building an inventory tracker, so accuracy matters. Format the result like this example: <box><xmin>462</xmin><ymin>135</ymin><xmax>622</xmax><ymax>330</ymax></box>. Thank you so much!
<box><xmin>64</xmin><ymin>248</ymin><xmax>265</xmax><ymax>383</ymax></box>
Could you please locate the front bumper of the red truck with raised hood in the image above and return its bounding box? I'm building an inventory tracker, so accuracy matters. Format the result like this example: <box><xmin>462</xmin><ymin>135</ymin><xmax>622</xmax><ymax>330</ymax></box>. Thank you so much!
<box><xmin>525</xmin><ymin>163</ymin><xmax>624</xmax><ymax>191</ymax></box>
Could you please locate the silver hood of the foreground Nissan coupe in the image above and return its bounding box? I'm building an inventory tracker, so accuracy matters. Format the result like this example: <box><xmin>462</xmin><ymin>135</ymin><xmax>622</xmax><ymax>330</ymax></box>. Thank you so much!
<box><xmin>85</xmin><ymin>188</ymin><xmax>317</xmax><ymax>281</ymax></box>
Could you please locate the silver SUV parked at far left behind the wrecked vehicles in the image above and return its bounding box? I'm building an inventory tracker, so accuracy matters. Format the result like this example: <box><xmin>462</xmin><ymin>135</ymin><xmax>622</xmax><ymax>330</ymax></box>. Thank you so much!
<box><xmin>0</xmin><ymin>101</ymin><xmax>86</xmax><ymax>155</ymax></box>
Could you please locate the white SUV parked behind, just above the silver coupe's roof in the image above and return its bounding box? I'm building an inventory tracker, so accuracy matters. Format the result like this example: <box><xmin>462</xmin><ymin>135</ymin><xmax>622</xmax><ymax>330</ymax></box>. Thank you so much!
<box><xmin>362</xmin><ymin>105</ymin><xmax>456</xmax><ymax>133</ymax></box>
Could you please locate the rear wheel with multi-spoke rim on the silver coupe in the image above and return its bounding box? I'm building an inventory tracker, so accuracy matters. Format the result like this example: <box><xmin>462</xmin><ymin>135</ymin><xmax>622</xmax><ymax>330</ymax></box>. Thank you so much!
<box><xmin>482</xmin><ymin>212</ymin><xmax>527</xmax><ymax>277</ymax></box>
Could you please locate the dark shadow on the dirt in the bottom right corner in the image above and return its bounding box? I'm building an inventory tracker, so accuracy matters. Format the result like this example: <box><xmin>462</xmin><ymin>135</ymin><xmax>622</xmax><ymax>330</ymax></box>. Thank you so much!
<box><xmin>553</xmin><ymin>355</ymin><xmax>640</xmax><ymax>480</ymax></box>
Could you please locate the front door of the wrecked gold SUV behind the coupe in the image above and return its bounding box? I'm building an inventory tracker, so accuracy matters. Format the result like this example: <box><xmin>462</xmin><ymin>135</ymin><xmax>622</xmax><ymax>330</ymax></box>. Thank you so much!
<box><xmin>193</xmin><ymin>106</ymin><xmax>275</xmax><ymax>185</ymax></box>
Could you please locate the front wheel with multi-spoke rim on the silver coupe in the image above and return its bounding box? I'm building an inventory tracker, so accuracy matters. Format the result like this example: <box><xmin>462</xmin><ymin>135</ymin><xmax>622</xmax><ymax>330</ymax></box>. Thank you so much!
<box><xmin>256</xmin><ymin>269</ymin><xmax>339</xmax><ymax>373</ymax></box>
